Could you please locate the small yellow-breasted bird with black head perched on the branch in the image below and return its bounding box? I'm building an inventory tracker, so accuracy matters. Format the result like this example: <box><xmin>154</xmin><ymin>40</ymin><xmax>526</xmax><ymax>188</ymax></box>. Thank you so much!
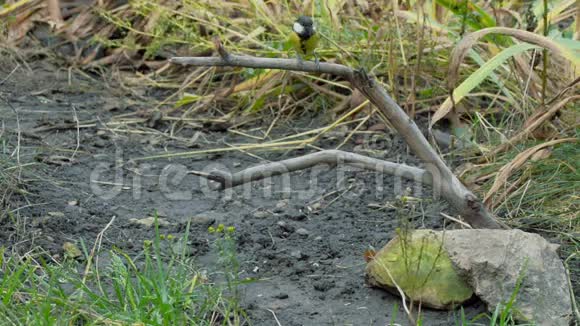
<box><xmin>288</xmin><ymin>16</ymin><xmax>320</xmax><ymax>63</ymax></box>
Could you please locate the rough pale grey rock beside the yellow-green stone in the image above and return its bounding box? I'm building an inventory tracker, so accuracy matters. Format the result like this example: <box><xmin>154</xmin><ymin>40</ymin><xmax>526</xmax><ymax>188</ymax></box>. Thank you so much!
<box><xmin>444</xmin><ymin>230</ymin><xmax>572</xmax><ymax>326</ymax></box>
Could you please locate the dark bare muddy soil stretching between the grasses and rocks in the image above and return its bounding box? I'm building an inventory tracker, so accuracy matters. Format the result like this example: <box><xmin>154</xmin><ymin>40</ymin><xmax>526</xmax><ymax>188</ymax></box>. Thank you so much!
<box><xmin>0</xmin><ymin>60</ymin><xmax>484</xmax><ymax>325</ymax></box>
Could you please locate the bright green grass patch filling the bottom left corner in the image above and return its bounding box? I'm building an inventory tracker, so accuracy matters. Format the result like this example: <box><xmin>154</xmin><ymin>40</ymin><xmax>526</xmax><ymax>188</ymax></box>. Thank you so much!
<box><xmin>0</xmin><ymin>219</ymin><xmax>245</xmax><ymax>325</ymax></box>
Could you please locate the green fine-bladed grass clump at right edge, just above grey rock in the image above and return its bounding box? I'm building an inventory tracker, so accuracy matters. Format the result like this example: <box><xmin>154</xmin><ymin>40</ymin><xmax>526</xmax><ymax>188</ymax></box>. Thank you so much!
<box><xmin>467</xmin><ymin>141</ymin><xmax>580</xmax><ymax>233</ymax></box>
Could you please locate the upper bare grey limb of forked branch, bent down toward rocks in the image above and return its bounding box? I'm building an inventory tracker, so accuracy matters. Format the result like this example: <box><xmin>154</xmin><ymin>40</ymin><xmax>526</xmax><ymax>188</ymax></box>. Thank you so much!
<box><xmin>171</xmin><ymin>41</ymin><xmax>502</xmax><ymax>229</ymax></box>
